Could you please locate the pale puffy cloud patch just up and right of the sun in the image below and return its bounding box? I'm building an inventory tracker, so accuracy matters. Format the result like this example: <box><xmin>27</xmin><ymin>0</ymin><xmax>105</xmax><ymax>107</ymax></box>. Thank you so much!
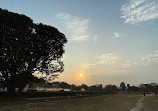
<box><xmin>95</xmin><ymin>54</ymin><xmax>118</xmax><ymax>65</ymax></box>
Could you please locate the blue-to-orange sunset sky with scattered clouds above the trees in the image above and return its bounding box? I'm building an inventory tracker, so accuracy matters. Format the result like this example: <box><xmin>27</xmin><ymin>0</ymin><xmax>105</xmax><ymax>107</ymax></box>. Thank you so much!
<box><xmin>0</xmin><ymin>0</ymin><xmax>158</xmax><ymax>86</ymax></box>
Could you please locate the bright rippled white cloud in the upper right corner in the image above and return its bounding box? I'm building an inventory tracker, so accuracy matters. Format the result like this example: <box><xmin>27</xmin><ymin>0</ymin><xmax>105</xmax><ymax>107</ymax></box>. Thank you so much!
<box><xmin>121</xmin><ymin>0</ymin><xmax>158</xmax><ymax>24</ymax></box>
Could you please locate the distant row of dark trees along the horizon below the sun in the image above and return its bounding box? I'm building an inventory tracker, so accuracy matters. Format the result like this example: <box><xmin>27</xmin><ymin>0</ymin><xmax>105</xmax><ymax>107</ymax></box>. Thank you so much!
<box><xmin>28</xmin><ymin>81</ymin><xmax>158</xmax><ymax>94</ymax></box>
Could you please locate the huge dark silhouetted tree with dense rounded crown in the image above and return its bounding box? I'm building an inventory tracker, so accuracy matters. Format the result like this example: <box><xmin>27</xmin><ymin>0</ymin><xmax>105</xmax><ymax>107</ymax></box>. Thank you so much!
<box><xmin>0</xmin><ymin>9</ymin><xmax>67</xmax><ymax>93</ymax></box>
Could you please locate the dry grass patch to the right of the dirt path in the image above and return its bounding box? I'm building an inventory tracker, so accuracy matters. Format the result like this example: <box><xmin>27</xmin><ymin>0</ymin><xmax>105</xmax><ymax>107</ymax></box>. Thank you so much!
<box><xmin>141</xmin><ymin>95</ymin><xmax>158</xmax><ymax>111</ymax></box>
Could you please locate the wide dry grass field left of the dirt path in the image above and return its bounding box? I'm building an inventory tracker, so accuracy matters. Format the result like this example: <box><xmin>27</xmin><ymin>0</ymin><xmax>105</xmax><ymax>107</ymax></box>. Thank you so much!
<box><xmin>0</xmin><ymin>94</ymin><xmax>142</xmax><ymax>111</ymax></box>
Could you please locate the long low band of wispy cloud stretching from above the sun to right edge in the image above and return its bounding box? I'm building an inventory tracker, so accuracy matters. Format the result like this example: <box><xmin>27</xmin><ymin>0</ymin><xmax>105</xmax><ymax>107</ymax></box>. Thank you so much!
<box><xmin>80</xmin><ymin>50</ymin><xmax>158</xmax><ymax>72</ymax></box>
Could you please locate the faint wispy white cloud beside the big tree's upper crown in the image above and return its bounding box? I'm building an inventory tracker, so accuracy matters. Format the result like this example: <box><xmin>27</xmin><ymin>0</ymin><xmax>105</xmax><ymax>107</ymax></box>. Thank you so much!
<box><xmin>56</xmin><ymin>13</ymin><xmax>90</xmax><ymax>42</ymax></box>
